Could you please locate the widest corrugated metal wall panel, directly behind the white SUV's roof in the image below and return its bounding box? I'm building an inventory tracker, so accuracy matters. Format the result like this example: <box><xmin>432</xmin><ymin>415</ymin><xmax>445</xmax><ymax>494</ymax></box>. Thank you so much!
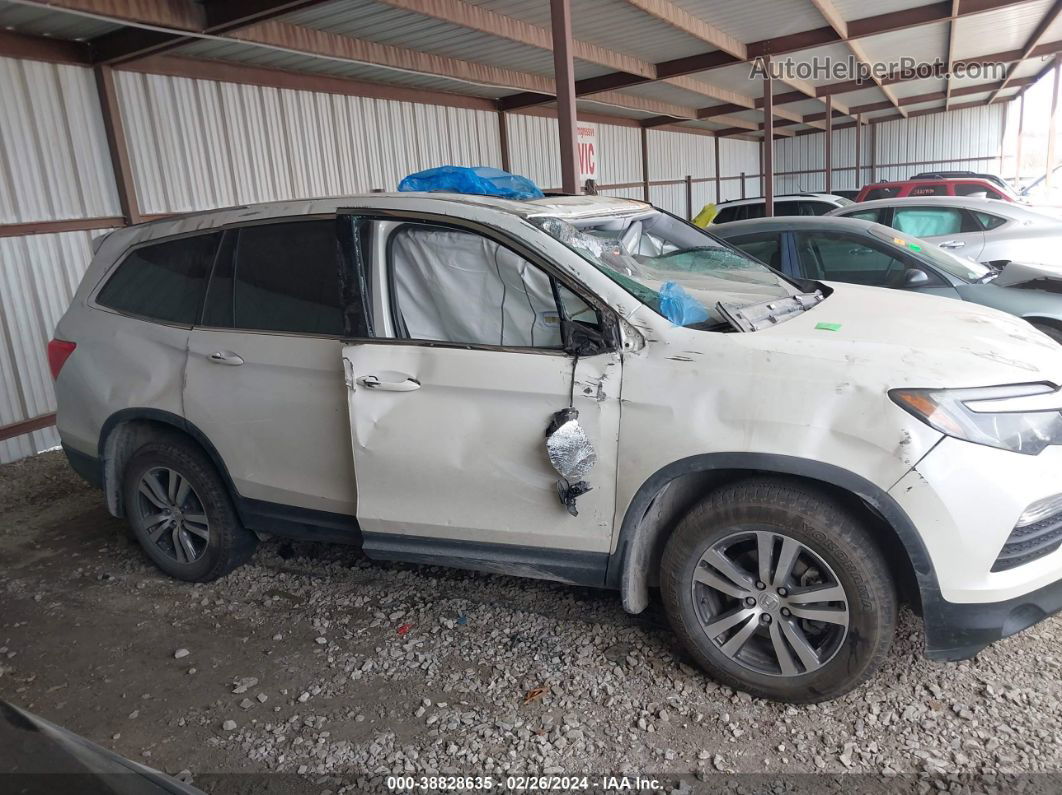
<box><xmin>116</xmin><ymin>72</ymin><xmax>501</xmax><ymax>213</ymax></box>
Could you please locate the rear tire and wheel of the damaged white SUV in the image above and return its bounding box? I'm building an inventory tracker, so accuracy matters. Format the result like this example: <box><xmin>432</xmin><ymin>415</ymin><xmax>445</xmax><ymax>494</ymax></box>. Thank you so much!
<box><xmin>122</xmin><ymin>436</ymin><xmax>258</xmax><ymax>583</ymax></box>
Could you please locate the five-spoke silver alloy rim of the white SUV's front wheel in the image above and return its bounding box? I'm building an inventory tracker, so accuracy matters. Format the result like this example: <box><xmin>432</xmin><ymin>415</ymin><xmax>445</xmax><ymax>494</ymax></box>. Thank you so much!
<box><xmin>691</xmin><ymin>529</ymin><xmax>849</xmax><ymax>676</ymax></box>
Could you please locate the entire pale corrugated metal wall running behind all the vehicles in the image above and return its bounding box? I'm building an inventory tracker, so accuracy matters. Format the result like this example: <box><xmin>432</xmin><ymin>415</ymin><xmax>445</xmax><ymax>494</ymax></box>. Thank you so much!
<box><xmin>0</xmin><ymin>52</ymin><xmax>1003</xmax><ymax>462</ymax></box>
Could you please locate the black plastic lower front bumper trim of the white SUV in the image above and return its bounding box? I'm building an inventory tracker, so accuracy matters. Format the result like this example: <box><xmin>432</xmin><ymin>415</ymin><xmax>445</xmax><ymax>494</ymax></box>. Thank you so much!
<box><xmin>925</xmin><ymin>580</ymin><xmax>1062</xmax><ymax>661</ymax></box>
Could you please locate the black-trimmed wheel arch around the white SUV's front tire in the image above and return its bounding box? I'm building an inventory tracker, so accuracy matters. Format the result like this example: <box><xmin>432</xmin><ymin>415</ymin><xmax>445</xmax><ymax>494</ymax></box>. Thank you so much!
<box><xmin>605</xmin><ymin>453</ymin><xmax>940</xmax><ymax>612</ymax></box>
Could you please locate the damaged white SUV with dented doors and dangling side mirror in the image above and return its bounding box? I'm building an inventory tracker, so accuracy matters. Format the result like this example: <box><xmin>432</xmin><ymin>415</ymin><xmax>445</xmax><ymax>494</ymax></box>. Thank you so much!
<box><xmin>49</xmin><ymin>193</ymin><xmax>1062</xmax><ymax>702</ymax></box>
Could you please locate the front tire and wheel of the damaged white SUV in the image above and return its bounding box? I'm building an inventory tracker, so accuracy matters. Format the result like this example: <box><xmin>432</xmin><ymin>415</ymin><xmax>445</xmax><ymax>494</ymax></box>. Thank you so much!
<box><xmin>661</xmin><ymin>479</ymin><xmax>896</xmax><ymax>704</ymax></box>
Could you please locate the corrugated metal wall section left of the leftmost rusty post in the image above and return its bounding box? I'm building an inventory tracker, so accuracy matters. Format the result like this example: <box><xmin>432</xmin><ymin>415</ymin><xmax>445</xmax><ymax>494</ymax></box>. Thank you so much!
<box><xmin>0</xmin><ymin>58</ymin><xmax>121</xmax><ymax>462</ymax></box>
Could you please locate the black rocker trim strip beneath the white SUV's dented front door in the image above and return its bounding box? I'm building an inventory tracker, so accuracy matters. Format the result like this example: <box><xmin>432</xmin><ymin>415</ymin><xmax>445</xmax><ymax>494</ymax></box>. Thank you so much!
<box><xmin>362</xmin><ymin>533</ymin><xmax>609</xmax><ymax>587</ymax></box>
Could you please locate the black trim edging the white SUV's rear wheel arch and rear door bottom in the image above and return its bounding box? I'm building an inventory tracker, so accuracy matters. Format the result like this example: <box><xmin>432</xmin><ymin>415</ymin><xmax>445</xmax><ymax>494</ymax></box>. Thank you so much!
<box><xmin>92</xmin><ymin>409</ymin><xmax>361</xmax><ymax>543</ymax></box>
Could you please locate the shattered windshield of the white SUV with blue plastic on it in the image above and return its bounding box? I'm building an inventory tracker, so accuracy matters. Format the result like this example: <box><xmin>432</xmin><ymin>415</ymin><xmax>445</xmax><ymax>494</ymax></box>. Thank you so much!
<box><xmin>531</xmin><ymin>210</ymin><xmax>800</xmax><ymax>328</ymax></box>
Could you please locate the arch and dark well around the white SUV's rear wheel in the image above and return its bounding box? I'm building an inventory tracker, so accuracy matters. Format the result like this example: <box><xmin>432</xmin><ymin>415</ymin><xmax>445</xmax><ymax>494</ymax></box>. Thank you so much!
<box><xmin>98</xmin><ymin>408</ymin><xmax>239</xmax><ymax>517</ymax></box>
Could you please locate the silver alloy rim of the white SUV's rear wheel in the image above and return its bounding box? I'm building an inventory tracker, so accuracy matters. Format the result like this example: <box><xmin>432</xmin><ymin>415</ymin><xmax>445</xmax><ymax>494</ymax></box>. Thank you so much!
<box><xmin>137</xmin><ymin>467</ymin><xmax>210</xmax><ymax>564</ymax></box>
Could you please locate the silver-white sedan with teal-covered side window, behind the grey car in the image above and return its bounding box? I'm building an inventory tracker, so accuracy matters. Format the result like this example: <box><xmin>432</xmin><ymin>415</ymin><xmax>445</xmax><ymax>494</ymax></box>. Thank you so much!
<box><xmin>827</xmin><ymin>196</ymin><xmax>1062</xmax><ymax>267</ymax></box>
